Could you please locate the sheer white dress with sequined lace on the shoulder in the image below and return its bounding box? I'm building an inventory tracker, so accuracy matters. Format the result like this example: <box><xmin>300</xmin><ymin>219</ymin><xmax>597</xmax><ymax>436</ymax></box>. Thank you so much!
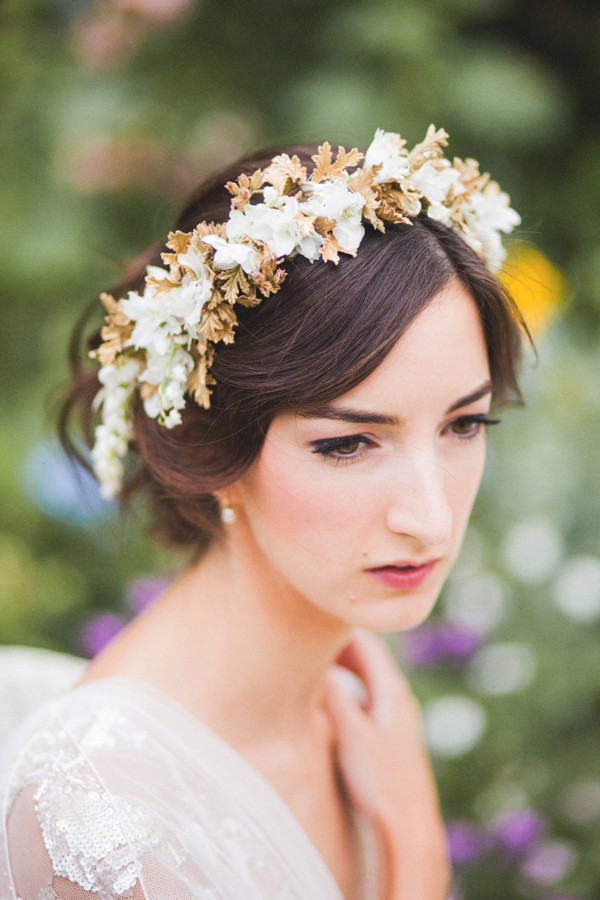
<box><xmin>0</xmin><ymin>677</ymin><xmax>373</xmax><ymax>900</ymax></box>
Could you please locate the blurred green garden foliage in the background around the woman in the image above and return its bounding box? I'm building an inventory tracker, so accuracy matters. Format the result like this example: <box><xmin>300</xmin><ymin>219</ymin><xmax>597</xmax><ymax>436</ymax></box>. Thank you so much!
<box><xmin>0</xmin><ymin>0</ymin><xmax>600</xmax><ymax>900</ymax></box>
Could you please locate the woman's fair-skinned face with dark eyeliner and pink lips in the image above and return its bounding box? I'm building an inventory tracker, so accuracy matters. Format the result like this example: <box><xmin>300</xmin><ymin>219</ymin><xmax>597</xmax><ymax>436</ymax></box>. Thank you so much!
<box><xmin>231</xmin><ymin>281</ymin><xmax>491</xmax><ymax>631</ymax></box>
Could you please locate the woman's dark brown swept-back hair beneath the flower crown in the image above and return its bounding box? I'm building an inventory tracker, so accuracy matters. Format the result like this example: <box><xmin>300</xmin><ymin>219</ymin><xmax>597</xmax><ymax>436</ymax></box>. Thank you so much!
<box><xmin>61</xmin><ymin>146</ymin><xmax>522</xmax><ymax>551</ymax></box>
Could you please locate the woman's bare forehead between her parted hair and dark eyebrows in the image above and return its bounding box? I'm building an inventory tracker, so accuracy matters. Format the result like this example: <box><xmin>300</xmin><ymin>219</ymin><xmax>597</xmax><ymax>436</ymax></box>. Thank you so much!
<box><xmin>333</xmin><ymin>280</ymin><xmax>490</xmax><ymax>409</ymax></box>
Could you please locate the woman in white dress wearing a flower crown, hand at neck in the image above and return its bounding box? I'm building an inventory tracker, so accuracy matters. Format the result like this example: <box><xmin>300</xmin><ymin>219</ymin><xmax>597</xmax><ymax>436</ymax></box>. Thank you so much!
<box><xmin>0</xmin><ymin>126</ymin><xmax>519</xmax><ymax>900</ymax></box>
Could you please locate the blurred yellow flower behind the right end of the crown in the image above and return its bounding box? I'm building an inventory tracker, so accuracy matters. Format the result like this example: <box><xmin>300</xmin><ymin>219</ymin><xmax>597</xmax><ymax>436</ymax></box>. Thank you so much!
<box><xmin>499</xmin><ymin>243</ymin><xmax>567</xmax><ymax>336</ymax></box>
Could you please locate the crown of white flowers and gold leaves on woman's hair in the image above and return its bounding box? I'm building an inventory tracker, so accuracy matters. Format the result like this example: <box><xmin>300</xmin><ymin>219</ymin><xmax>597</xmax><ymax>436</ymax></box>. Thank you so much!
<box><xmin>90</xmin><ymin>125</ymin><xmax>520</xmax><ymax>499</ymax></box>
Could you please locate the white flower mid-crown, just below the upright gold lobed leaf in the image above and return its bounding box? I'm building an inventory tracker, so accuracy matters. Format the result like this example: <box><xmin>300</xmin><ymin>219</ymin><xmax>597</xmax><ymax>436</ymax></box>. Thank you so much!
<box><xmin>300</xmin><ymin>178</ymin><xmax>365</xmax><ymax>253</ymax></box>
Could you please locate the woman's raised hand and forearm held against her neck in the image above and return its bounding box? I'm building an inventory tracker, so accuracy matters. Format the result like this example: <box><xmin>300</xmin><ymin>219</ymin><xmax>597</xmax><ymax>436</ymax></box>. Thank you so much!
<box><xmin>328</xmin><ymin>630</ymin><xmax>450</xmax><ymax>900</ymax></box>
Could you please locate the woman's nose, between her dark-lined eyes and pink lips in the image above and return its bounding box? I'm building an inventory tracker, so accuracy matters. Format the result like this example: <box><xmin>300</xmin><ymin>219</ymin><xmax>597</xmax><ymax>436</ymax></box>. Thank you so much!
<box><xmin>386</xmin><ymin>449</ymin><xmax>453</xmax><ymax>547</ymax></box>
